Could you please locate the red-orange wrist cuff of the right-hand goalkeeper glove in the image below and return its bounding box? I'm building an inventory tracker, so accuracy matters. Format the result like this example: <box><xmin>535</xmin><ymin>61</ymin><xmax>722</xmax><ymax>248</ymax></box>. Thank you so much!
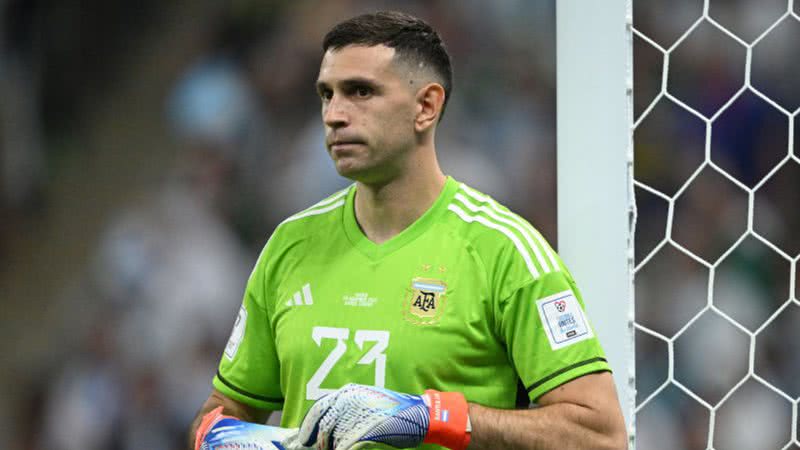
<box><xmin>424</xmin><ymin>390</ymin><xmax>470</xmax><ymax>450</ymax></box>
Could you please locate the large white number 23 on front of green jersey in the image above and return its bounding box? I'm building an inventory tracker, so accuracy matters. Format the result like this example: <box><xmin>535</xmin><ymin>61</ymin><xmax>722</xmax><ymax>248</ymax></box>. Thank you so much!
<box><xmin>306</xmin><ymin>327</ymin><xmax>389</xmax><ymax>400</ymax></box>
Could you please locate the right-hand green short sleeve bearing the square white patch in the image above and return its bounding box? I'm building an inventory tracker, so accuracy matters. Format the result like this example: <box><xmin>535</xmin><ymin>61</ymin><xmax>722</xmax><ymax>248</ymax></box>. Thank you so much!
<box><xmin>499</xmin><ymin>267</ymin><xmax>610</xmax><ymax>401</ymax></box>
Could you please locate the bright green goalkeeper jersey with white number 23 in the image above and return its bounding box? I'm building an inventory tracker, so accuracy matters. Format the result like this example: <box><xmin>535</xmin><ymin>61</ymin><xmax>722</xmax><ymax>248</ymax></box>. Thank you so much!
<box><xmin>214</xmin><ymin>178</ymin><xmax>609</xmax><ymax>448</ymax></box>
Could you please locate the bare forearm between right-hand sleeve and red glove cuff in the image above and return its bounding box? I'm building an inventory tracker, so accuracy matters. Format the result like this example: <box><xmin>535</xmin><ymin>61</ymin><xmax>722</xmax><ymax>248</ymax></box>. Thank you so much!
<box><xmin>468</xmin><ymin>372</ymin><xmax>628</xmax><ymax>450</ymax></box>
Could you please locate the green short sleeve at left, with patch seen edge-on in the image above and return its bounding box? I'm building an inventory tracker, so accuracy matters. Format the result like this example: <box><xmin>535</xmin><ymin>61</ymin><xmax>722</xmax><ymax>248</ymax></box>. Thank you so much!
<box><xmin>213</xmin><ymin>244</ymin><xmax>283</xmax><ymax>410</ymax></box>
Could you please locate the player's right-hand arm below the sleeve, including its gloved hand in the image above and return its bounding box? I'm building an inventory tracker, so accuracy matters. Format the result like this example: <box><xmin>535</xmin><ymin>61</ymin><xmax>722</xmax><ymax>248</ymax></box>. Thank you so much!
<box><xmin>298</xmin><ymin>372</ymin><xmax>627</xmax><ymax>450</ymax></box>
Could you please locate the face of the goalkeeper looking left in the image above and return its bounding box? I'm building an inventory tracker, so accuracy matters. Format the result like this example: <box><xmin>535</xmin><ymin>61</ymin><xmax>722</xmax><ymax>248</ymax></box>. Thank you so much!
<box><xmin>317</xmin><ymin>45</ymin><xmax>418</xmax><ymax>183</ymax></box>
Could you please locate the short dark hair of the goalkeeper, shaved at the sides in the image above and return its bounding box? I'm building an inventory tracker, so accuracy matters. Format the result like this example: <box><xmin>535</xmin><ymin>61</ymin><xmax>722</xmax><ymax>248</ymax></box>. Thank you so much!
<box><xmin>322</xmin><ymin>11</ymin><xmax>453</xmax><ymax>119</ymax></box>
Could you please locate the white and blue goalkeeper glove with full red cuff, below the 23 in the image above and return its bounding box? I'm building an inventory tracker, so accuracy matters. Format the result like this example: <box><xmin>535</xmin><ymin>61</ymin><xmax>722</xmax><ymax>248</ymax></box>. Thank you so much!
<box><xmin>298</xmin><ymin>384</ymin><xmax>470</xmax><ymax>450</ymax></box>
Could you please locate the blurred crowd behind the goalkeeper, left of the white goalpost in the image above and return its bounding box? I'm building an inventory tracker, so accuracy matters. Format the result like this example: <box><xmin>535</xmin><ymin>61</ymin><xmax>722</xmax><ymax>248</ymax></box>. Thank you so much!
<box><xmin>0</xmin><ymin>0</ymin><xmax>555</xmax><ymax>450</ymax></box>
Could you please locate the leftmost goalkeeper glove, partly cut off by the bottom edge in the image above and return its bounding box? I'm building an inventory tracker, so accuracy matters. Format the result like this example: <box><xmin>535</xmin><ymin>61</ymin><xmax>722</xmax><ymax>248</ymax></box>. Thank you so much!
<box><xmin>194</xmin><ymin>406</ymin><xmax>302</xmax><ymax>450</ymax></box>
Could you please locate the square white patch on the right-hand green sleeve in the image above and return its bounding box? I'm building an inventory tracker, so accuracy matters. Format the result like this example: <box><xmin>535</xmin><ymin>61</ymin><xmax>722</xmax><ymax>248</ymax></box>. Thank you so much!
<box><xmin>536</xmin><ymin>290</ymin><xmax>594</xmax><ymax>350</ymax></box>
